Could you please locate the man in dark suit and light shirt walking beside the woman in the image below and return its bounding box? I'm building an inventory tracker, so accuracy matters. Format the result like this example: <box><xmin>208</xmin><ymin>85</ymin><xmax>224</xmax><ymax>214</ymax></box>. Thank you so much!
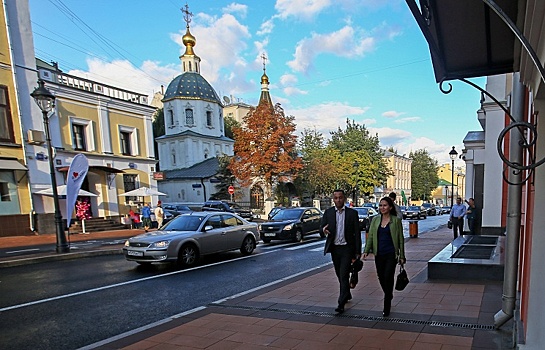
<box><xmin>320</xmin><ymin>190</ymin><xmax>361</xmax><ymax>313</ymax></box>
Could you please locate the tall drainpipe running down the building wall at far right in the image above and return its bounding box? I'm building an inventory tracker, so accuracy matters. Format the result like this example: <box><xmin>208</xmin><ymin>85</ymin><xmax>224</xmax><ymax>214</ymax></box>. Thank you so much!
<box><xmin>494</xmin><ymin>73</ymin><xmax>525</xmax><ymax>328</ymax></box>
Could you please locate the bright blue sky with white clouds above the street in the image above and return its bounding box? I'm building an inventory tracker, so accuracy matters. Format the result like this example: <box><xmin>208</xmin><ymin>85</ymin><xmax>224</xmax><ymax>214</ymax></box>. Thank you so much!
<box><xmin>29</xmin><ymin>0</ymin><xmax>485</xmax><ymax>165</ymax></box>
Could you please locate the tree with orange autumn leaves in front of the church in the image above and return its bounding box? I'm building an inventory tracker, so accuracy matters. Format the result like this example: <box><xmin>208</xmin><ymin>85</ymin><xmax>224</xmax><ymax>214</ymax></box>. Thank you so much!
<box><xmin>229</xmin><ymin>103</ymin><xmax>303</xmax><ymax>197</ymax></box>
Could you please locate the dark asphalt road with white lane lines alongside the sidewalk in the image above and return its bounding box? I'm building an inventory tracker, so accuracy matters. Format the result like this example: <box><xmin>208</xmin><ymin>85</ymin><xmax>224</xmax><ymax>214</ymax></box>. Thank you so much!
<box><xmin>0</xmin><ymin>216</ymin><xmax>448</xmax><ymax>349</ymax></box>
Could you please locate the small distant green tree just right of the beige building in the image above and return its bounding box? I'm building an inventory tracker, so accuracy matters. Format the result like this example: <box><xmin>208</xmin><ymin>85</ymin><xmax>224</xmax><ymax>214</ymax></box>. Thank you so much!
<box><xmin>409</xmin><ymin>149</ymin><xmax>439</xmax><ymax>200</ymax></box>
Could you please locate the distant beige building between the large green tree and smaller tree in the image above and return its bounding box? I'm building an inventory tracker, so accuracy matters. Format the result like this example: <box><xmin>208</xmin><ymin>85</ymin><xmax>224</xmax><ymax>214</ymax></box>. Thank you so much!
<box><xmin>377</xmin><ymin>151</ymin><xmax>413</xmax><ymax>205</ymax></box>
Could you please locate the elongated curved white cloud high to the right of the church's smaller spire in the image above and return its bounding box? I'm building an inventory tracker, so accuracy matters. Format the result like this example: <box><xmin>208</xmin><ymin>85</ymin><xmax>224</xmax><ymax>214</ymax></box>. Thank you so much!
<box><xmin>287</xmin><ymin>26</ymin><xmax>375</xmax><ymax>73</ymax></box>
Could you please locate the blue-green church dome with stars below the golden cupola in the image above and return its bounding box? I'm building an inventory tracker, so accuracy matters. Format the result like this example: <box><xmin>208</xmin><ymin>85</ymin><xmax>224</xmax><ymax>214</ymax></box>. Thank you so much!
<box><xmin>163</xmin><ymin>72</ymin><xmax>221</xmax><ymax>105</ymax></box>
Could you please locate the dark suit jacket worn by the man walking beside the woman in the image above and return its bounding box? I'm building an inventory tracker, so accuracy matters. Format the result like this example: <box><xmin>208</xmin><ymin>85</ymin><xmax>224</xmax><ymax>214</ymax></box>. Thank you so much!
<box><xmin>320</xmin><ymin>206</ymin><xmax>361</xmax><ymax>257</ymax></box>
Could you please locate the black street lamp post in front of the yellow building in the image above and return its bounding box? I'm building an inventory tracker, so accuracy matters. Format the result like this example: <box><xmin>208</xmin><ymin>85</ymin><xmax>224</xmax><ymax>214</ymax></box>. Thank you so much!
<box><xmin>30</xmin><ymin>79</ymin><xmax>70</xmax><ymax>253</ymax></box>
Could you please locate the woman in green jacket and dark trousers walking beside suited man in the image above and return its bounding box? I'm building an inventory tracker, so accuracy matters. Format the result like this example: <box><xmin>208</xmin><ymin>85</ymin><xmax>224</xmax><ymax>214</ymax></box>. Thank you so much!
<box><xmin>363</xmin><ymin>197</ymin><xmax>406</xmax><ymax>317</ymax></box>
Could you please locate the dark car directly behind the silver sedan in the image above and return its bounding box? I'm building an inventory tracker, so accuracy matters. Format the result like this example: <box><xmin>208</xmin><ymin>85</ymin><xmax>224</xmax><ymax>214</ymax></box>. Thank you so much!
<box><xmin>259</xmin><ymin>207</ymin><xmax>325</xmax><ymax>243</ymax></box>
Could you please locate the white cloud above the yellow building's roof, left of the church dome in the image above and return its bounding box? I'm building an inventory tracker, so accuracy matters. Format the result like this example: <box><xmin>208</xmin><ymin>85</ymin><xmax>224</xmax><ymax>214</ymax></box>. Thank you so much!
<box><xmin>68</xmin><ymin>58</ymin><xmax>178</xmax><ymax>96</ymax></box>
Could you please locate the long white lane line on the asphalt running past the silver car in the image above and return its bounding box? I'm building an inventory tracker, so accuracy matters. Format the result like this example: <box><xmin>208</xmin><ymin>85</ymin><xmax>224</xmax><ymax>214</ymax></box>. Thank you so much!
<box><xmin>0</xmin><ymin>251</ymin><xmax>273</xmax><ymax>312</ymax></box>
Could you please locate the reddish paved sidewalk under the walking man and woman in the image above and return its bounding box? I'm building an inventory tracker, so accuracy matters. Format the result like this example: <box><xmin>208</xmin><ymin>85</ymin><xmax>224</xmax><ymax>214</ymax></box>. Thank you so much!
<box><xmin>0</xmin><ymin>227</ymin><xmax>512</xmax><ymax>350</ymax></box>
